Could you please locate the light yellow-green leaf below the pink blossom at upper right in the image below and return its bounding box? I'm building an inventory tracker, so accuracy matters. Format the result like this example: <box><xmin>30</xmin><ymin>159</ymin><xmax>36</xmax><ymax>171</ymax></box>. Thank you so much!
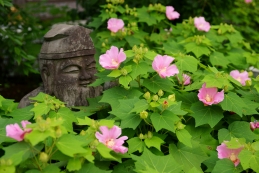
<box><xmin>184</xmin><ymin>43</ymin><xmax>210</xmax><ymax>58</ymax></box>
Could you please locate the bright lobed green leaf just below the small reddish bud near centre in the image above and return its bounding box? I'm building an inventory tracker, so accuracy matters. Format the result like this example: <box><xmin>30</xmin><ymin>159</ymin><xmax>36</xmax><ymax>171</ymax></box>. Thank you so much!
<box><xmin>150</xmin><ymin>110</ymin><xmax>180</xmax><ymax>132</ymax></box>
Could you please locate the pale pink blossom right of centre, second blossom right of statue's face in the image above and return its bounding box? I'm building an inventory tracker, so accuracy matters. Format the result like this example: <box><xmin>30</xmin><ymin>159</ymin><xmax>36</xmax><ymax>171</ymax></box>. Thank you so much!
<box><xmin>152</xmin><ymin>55</ymin><xmax>179</xmax><ymax>78</ymax></box>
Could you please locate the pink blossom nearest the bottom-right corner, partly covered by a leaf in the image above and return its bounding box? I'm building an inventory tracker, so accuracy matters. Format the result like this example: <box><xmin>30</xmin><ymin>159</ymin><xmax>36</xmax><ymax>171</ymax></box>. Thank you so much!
<box><xmin>217</xmin><ymin>141</ymin><xmax>244</xmax><ymax>166</ymax></box>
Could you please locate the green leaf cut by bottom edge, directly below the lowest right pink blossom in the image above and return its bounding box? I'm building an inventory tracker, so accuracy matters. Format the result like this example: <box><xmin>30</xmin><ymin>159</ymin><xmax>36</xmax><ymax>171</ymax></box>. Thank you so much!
<box><xmin>211</xmin><ymin>159</ymin><xmax>243</xmax><ymax>173</ymax></box>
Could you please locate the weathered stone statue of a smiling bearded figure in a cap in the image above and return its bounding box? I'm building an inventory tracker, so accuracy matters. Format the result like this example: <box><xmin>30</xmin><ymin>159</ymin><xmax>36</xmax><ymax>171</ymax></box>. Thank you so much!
<box><xmin>18</xmin><ymin>24</ymin><xmax>103</xmax><ymax>108</ymax></box>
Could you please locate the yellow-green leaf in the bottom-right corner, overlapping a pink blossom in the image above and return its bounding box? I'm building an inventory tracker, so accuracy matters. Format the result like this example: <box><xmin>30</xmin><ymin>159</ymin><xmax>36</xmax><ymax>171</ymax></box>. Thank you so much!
<box><xmin>238</xmin><ymin>150</ymin><xmax>259</xmax><ymax>172</ymax></box>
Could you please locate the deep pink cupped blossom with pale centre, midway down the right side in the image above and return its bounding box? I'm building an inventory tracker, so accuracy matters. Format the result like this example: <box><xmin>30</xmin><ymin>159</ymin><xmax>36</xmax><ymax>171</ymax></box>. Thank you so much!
<box><xmin>198</xmin><ymin>83</ymin><xmax>224</xmax><ymax>106</ymax></box>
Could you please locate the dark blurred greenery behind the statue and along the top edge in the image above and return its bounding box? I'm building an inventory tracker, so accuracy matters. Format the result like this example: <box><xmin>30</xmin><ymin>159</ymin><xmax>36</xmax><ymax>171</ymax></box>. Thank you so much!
<box><xmin>0</xmin><ymin>0</ymin><xmax>259</xmax><ymax>101</ymax></box>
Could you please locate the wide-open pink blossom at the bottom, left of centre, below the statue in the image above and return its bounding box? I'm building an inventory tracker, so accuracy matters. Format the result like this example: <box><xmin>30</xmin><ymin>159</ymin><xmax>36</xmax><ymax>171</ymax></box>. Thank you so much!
<box><xmin>95</xmin><ymin>126</ymin><xmax>128</xmax><ymax>154</ymax></box>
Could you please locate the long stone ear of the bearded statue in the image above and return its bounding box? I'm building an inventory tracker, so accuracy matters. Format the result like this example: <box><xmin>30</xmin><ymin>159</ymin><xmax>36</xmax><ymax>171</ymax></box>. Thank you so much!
<box><xmin>41</xmin><ymin>64</ymin><xmax>53</xmax><ymax>94</ymax></box>
